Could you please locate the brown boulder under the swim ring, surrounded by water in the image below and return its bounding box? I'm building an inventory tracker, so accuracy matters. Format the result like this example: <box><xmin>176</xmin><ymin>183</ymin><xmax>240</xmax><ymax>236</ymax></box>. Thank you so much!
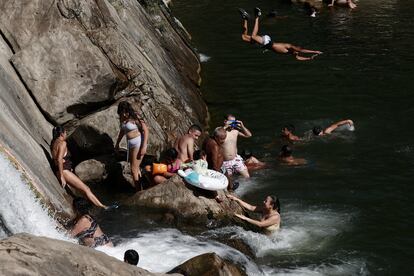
<box><xmin>123</xmin><ymin>175</ymin><xmax>243</xmax><ymax>224</ymax></box>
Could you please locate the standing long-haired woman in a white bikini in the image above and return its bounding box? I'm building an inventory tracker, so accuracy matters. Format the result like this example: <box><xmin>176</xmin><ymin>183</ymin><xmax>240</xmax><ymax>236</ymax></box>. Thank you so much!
<box><xmin>115</xmin><ymin>101</ymin><xmax>149</xmax><ymax>190</ymax></box>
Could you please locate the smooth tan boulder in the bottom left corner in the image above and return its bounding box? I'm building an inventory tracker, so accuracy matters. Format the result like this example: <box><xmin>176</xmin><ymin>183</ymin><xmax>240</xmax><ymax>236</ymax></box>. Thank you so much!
<box><xmin>0</xmin><ymin>234</ymin><xmax>179</xmax><ymax>276</ymax></box>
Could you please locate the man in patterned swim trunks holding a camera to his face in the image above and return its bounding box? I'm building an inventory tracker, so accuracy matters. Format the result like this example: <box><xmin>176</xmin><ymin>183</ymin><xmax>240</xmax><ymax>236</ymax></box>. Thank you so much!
<box><xmin>221</xmin><ymin>114</ymin><xmax>252</xmax><ymax>178</ymax></box>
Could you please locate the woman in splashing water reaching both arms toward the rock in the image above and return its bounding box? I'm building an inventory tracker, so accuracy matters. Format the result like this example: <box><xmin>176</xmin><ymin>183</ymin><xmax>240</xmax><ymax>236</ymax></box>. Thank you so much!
<box><xmin>227</xmin><ymin>194</ymin><xmax>280</xmax><ymax>235</ymax></box>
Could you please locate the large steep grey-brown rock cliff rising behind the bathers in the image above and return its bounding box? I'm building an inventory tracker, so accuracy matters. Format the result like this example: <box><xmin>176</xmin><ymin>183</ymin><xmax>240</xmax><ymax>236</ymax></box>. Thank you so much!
<box><xmin>0</xmin><ymin>0</ymin><xmax>208</xmax><ymax>220</ymax></box>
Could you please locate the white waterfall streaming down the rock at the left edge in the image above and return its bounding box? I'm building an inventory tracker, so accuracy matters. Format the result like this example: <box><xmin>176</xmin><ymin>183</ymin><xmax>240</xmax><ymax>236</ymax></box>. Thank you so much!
<box><xmin>0</xmin><ymin>152</ymin><xmax>68</xmax><ymax>240</ymax></box>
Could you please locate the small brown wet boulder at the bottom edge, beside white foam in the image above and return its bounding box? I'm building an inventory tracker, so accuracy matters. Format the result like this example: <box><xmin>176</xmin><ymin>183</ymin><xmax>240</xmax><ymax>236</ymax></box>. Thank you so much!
<box><xmin>168</xmin><ymin>253</ymin><xmax>246</xmax><ymax>276</ymax></box>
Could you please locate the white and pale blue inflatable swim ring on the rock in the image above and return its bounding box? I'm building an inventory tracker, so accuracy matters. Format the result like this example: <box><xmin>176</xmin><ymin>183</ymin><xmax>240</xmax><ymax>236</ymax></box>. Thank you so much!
<box><xmin>178</xmin><ymin>169</ymin><xmax>229</xmax><ymax>191</ymax></box>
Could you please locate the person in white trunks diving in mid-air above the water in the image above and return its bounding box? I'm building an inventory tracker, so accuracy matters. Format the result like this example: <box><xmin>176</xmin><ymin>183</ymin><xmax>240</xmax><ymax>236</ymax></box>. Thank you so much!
<box><xmin>239</xmin><ymin>7</ymin><xmax>322</xmax><ymax>61</ymax></box>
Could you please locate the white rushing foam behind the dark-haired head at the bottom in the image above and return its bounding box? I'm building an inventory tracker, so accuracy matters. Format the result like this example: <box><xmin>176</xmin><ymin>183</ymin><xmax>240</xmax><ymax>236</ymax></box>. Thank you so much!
<box><xmin>98</xmin><ymin>228</ymin><xmax>263</xmax><ymax>275</ymax></box>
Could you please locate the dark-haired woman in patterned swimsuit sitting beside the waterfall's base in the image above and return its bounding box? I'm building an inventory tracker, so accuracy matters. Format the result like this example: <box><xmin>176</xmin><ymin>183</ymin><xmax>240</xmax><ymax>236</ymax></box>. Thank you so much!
<box><xmin>70</xmin><ymin>197</ymin><xmax>113</xmax><ymax>247</ymax></box>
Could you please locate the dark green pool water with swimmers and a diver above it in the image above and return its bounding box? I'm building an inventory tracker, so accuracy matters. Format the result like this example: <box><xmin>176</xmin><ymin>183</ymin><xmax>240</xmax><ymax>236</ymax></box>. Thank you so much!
<box><xmin>172</xmin><ymin>0</ymin><xmax>414</xmax><ymax>275</ymax></box>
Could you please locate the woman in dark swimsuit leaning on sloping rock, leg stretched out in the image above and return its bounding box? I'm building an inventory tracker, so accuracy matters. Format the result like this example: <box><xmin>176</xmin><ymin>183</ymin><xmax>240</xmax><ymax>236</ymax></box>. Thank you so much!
<box><xmin>50</xmin><ymin>126</ymin><xmax>108</xmax><ymax>209</ymax></box>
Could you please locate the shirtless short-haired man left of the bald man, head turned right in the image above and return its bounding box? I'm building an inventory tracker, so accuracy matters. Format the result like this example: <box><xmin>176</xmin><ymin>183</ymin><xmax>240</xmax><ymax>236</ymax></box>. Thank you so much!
<box><xmin>174</xmin><ymin>125</ymin><xmax>202</xmax><ymax>162</ymax></box>
